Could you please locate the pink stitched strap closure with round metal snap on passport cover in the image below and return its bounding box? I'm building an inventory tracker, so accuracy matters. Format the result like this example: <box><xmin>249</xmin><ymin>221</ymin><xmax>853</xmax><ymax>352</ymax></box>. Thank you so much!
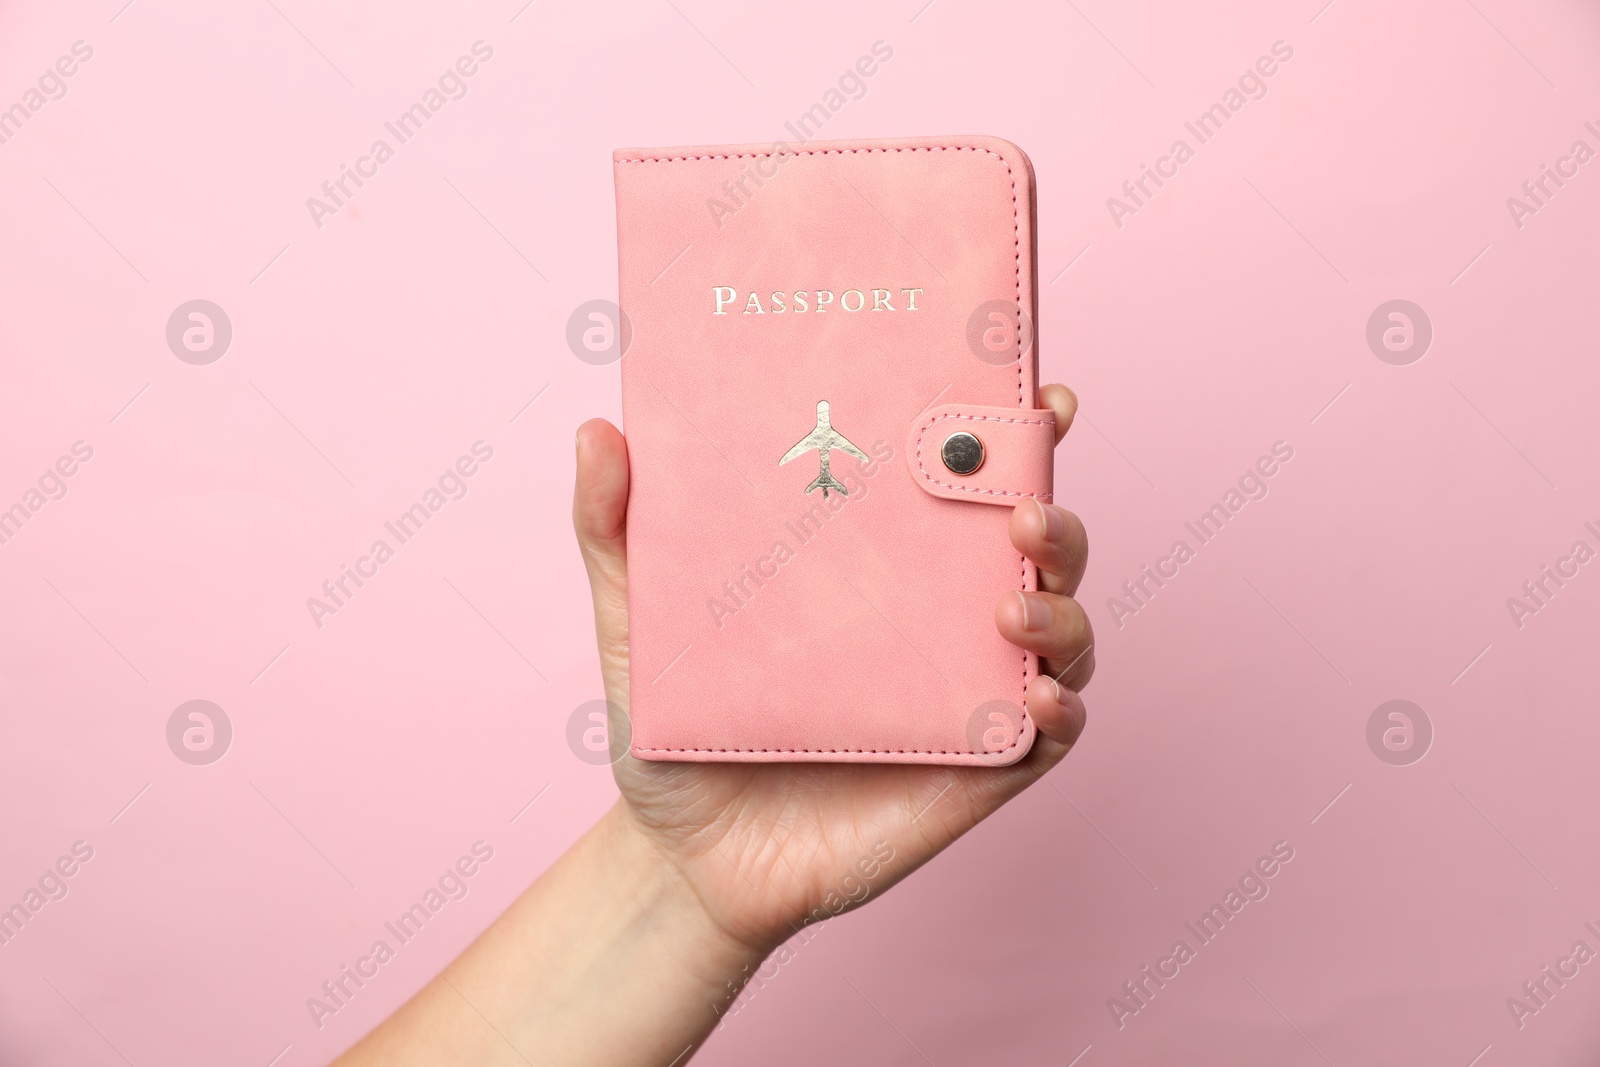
<box><xmin>906</xmin><ymin>405</ymin><xmax>1056</xmax><ymax>507</ymax></box>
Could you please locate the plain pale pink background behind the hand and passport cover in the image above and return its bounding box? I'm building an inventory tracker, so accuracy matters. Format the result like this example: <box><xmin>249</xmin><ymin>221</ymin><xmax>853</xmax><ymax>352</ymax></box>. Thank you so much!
<box><xmin>0</xmin><ymin>0</ymin><xmax>1600</xmax><ymax>1067</ymax></box>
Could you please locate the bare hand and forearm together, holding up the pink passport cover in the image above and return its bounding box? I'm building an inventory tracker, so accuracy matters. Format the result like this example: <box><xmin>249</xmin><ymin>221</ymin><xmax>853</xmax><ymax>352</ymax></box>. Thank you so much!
<box><xmin>339</xmin><ymin>386</ymin><xmax>1094</xmax><ymax>1067</ymax></box>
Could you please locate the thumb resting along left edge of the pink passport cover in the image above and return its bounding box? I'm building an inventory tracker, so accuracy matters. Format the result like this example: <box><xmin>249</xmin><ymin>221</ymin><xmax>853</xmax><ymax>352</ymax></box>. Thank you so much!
<box><xmin>573</xmin><ymin>419</ymin><xmax>627</xmax><ymax>671</ymax></box>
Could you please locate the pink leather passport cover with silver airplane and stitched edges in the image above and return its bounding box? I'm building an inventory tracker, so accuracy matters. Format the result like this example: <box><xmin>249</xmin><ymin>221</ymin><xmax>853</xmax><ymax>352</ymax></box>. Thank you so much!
<box><xmin>614</xmin><ymin>136</ymin><xmax>1054</xmax><ymax>765</ymax></box>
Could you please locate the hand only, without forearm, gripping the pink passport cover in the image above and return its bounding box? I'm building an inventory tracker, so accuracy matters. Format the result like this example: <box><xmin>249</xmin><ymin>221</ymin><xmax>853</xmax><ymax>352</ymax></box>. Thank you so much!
<box><xmin>573</xmin><ymin>386</ymin><xmax>1094</xmax><ymax>957</ymax></box>
